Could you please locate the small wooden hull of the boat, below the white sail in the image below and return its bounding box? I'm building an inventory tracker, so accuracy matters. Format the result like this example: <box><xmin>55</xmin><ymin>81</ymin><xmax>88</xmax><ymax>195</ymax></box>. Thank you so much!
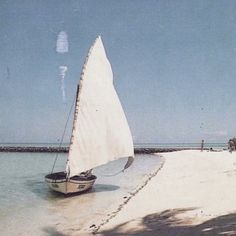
<box><xmin>45</xmin><ymin>172</ymin><xmax>97</xmax><ymax>194</ymax></box>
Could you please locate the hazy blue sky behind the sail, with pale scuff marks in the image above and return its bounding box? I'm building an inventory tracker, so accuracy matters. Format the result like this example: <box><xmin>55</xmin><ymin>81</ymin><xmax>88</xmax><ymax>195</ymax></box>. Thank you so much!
<box><xmin>0</xmin><ymin>0</ymin><xmax>236</xmax><ymax>143</ymax></box>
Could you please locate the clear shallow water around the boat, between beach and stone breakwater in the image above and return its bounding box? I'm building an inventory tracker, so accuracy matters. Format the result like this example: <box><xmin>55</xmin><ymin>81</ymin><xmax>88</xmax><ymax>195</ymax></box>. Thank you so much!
<box><xmin>0</xmin><ymin>153</ymin><xmax>162</xmax><ymax>235</ymax></box>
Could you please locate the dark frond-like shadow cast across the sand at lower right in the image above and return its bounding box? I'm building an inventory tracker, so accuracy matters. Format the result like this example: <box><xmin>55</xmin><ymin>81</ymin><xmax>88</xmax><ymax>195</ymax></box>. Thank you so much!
<box><xmin>99</xmin><ymin>208</ymin><xmax>236</xmax><ymax>236</ymax></box>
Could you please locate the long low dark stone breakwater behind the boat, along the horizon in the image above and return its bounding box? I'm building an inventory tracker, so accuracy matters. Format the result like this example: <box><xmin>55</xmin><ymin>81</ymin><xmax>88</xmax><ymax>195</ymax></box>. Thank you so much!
<box><xmin>0</xmin><ymin>146</ymin><xmax>209</xmax><ymax>154</ymax></box>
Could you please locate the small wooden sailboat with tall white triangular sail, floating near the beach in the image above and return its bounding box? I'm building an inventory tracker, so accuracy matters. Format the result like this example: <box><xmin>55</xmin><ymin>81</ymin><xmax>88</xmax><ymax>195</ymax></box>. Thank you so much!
<box><xmin>45</xmin><ymin>36</ymin><xmax>134</xmax><ymax>194</ymax></box>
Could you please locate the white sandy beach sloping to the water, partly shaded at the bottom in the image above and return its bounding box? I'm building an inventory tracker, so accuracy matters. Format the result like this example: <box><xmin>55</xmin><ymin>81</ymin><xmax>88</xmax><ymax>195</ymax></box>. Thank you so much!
<box><xmin>99</xmin><ymin>151</ymin><xmax>236</xmax><ymax>235</ymax></box>
